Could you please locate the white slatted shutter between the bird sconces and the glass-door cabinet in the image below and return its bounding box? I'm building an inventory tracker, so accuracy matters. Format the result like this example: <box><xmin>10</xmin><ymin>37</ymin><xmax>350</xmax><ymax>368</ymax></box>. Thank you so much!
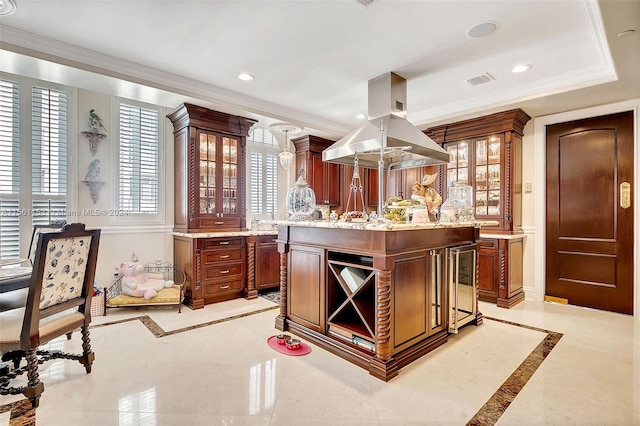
<box><xmin>118</xmin><ymin>103</ymin><xmax>159</xmax><ymax>214</ymax></box>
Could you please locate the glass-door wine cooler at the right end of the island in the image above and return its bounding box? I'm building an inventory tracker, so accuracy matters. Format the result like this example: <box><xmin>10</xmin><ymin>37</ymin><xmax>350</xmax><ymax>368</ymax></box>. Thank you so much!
<box><xmin>447</xmin><ymin>244</ymin><xmax>478</xmax><ymax>333</ymax></box>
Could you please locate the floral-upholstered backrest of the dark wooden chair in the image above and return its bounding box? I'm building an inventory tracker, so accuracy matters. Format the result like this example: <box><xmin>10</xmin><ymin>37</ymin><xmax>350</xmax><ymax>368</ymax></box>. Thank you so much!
<box><xmin>21</xmin><ymin>223</ymin><xmax>100</xmax><ymax>347</ymax></box>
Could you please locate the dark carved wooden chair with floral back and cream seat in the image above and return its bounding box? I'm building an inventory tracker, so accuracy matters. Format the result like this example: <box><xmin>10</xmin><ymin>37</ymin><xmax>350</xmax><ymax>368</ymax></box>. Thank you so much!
<box><xmin>0</xmin><ymin>223</ymin><xmax>100</xmax><ymax>408</ymax></box>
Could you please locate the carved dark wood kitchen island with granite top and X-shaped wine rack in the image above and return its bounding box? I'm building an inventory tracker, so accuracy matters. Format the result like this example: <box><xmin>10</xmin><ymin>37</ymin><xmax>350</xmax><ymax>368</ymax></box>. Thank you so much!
<box><xmin>275</xmin><ymin>221</ymin><xmax>482</xmax><ymax>381</ymax></box>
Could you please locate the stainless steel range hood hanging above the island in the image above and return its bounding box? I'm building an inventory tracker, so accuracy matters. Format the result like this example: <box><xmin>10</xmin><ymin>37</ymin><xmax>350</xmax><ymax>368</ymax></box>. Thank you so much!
<box><xmin>322</xmin><ymin>72</ymin><xmax>449</xmax><ymax>170</ymax></box>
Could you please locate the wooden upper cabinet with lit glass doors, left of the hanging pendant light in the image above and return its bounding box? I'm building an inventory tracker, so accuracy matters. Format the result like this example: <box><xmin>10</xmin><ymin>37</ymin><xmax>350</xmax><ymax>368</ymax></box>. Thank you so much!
<box><xmin>167</xmin><ymin>104</ymin><xmax>256</xmax><ymax>232</ymax></box>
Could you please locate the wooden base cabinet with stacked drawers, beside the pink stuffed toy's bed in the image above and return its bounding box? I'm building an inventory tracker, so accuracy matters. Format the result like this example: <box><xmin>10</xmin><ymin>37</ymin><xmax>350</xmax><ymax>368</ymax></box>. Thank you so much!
<box><xmin>173</xmin><ymin>236</ymin><xmax>246</xmax><ymax>309</ymax></box>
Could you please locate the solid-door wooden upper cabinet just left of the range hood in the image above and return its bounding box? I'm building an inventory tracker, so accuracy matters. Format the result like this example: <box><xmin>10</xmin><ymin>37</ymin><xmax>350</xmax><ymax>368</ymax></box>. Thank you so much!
<box><xmin>291</xmin><ymin>135</ymin><xmax>342</xmax><ymax>206</ymax></box>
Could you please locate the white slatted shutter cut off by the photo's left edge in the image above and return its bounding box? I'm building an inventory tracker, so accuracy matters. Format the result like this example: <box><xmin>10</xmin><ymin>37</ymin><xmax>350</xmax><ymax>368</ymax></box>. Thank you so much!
<box><xmin>0</xmin><ymin>80</ymin><xmax>20</xmax><ymax>258</ymax></box>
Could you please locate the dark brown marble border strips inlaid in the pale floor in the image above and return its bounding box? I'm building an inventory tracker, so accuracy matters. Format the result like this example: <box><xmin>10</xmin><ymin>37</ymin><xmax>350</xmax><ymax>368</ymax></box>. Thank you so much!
<box><xmin>0</xmin><ymin>306</ymin><xmax>563</xmax><ymax>426</ymax></box>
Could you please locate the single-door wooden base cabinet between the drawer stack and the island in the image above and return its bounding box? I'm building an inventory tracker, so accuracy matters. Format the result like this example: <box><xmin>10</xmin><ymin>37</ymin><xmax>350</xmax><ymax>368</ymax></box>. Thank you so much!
<box><xmin>245</xmin><ymin>235</ymin><xmax>280</xmax><ymax>299</ymax></box>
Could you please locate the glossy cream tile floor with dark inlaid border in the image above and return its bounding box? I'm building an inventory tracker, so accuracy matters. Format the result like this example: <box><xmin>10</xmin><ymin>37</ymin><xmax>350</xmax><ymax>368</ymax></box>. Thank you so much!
<box><xmin>0</xmin><ymin>298</ymin><xmax>640</xmax><ymax>426</ymax></box>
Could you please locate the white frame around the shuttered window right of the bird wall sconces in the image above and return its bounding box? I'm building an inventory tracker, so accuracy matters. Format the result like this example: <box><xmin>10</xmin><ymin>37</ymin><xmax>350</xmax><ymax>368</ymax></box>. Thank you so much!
<box><xmin>109</xmin><ymin>97</ymin><xmax>167</xmax><ymax>225</ymax></box>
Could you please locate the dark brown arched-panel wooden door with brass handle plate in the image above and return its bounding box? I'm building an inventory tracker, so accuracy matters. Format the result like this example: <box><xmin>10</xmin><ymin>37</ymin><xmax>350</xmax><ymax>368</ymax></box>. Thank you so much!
<box><xmin>546</xmin><ymin>112</ymin><xmax>634</xmax><ymax>314</ymax></box>
